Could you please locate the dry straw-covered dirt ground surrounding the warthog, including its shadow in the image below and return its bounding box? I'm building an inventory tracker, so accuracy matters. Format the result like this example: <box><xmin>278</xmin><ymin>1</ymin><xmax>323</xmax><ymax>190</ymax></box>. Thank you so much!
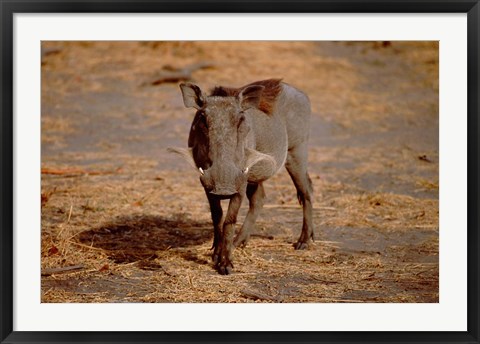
<box><xmin>41</xmin><ymin>42</ymin><xmax>439</xmax><ymax>303</ymax></box>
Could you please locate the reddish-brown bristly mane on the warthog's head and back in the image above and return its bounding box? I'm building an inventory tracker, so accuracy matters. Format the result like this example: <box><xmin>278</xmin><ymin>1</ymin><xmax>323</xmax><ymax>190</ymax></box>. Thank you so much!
<box><xmin>210</xmin><ymin>79</ymin><xmax>282</xmax><ymax>115</ymax></box>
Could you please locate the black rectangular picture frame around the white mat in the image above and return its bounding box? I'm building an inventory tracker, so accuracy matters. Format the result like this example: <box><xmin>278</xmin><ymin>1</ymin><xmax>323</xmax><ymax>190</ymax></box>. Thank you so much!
<box><xmin>0</xmin><ymin>0</ymin><xmax>480</xmax><ymax>343</ymax></box>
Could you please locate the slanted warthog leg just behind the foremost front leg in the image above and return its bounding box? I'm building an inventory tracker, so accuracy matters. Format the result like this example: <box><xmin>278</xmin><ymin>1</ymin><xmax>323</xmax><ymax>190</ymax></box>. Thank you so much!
<box><xmin>234</xmin><ymin>183</ymin><xmax>265</xmax><ymax>247</ymax></box>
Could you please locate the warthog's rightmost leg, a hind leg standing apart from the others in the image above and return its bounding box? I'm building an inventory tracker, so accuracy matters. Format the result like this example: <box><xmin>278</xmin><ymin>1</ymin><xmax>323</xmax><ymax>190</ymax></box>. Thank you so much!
<box><xmin>285</xmin><ymin>142</ymin><xmax>314</xmax><ymax>250</ymax></box>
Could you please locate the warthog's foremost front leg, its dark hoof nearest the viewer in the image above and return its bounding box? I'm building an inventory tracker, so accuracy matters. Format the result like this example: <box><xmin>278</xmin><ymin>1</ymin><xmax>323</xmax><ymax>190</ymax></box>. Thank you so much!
<box><xmin>216</xmin><ymin>193</ymin><xmax>243</xmax><ymax>275</ymax></box>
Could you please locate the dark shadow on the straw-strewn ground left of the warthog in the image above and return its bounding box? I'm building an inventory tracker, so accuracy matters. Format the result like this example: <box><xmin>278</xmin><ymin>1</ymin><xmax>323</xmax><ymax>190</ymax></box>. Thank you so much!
<box><xmin>79</xmin><ymin>215</ymin><xmax>212</xmax><ymax>263</ymax></box>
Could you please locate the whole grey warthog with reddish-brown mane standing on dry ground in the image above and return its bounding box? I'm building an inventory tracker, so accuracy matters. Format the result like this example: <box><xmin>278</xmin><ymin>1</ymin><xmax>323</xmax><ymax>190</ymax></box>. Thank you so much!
<box><xmin>169</xmin><ymin>79</ymin><xmax>313</xmax><ymax>274</ymax></box>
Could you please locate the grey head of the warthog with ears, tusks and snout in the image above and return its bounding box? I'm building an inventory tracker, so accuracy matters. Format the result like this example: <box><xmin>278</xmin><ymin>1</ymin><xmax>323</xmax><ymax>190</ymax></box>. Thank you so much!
<box><xmin>170</xmin><ymin>83</ymin><xmax>275</xmax><ymax>198</ymax></box>
